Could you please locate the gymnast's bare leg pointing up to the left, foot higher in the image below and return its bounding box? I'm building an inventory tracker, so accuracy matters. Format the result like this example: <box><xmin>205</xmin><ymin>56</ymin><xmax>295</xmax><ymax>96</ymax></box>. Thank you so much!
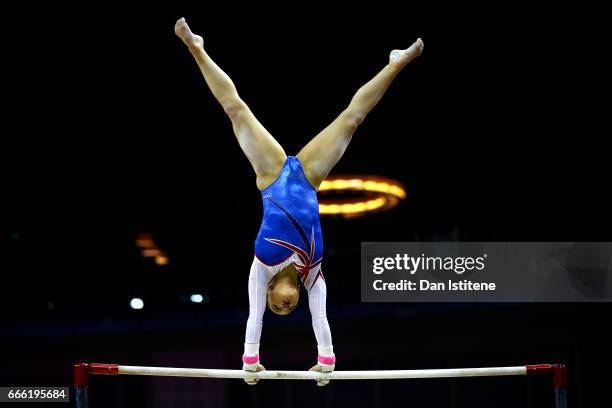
<box><xmin>174</xmin><ymin>18</ymin><xmax>287</xmax><ymax>190</ymax></box>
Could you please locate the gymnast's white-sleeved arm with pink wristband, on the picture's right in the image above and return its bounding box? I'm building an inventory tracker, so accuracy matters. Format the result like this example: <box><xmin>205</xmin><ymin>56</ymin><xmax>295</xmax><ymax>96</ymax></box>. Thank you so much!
<box><xmin>308</xmin><ymin>275</ymin><xmax>336</xmax><ymax>385</ymax></box>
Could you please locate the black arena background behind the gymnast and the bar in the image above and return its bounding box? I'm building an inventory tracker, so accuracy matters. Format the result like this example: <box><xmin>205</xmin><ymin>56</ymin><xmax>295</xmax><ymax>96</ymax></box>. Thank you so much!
<box><xmin>0</xmin><ymin>2</ymin><xmax>612</xmax><ymax>407</ymax></box>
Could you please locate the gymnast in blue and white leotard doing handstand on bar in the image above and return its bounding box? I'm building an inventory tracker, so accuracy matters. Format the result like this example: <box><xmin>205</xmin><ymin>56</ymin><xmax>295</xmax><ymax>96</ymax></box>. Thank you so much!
<box><xmin>174</xmin><ymin>18</ymin><xmax>423</xmax><ymax>385</ymax></box>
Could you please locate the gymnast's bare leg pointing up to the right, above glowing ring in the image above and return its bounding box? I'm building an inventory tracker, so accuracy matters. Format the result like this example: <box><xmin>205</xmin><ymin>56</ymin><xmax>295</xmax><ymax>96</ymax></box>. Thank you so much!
<box><xmin>297</xmin><ymin>38</ymin><xmax>423</xmax><ymax>189</ymax></box>
